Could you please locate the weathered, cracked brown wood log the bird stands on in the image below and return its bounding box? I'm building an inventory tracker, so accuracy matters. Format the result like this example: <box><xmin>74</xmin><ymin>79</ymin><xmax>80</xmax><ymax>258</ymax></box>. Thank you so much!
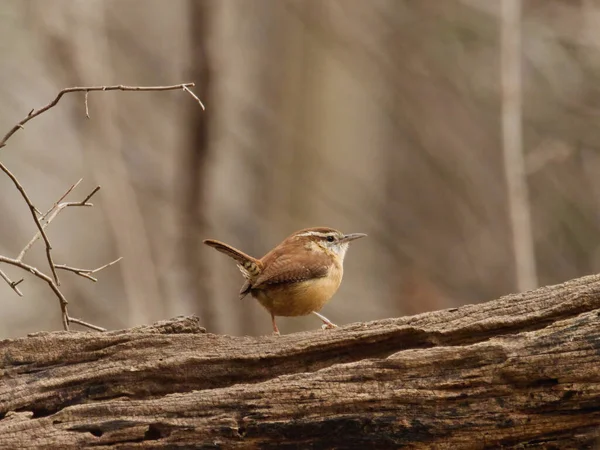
<box><xmin>0</xmin><ymin>276</ymin><xmax>600</xmax><ymax>449</ymax></box>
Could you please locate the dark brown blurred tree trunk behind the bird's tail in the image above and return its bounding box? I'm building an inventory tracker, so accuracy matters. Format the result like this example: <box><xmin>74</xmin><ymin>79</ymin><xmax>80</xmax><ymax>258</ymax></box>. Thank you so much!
<box><xmin>169</xmin><ymin>0</ymin><xmax>213</xmax><ymax>324</ymax></box>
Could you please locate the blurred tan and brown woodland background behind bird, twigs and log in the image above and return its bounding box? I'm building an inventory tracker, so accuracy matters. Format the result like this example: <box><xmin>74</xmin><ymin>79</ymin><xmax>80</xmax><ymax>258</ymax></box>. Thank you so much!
<box><xmin>0</xmin><ymin>0</ymin><xmax>600</xmax><ymax>337</ymax></box>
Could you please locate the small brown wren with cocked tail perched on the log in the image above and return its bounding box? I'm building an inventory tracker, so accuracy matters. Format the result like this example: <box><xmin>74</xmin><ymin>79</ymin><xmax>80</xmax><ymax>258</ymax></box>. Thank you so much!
<box><xmin>204</xmin><ymin>227</ymin><xmax>366</xmax><ymax>334</ymax></box>
